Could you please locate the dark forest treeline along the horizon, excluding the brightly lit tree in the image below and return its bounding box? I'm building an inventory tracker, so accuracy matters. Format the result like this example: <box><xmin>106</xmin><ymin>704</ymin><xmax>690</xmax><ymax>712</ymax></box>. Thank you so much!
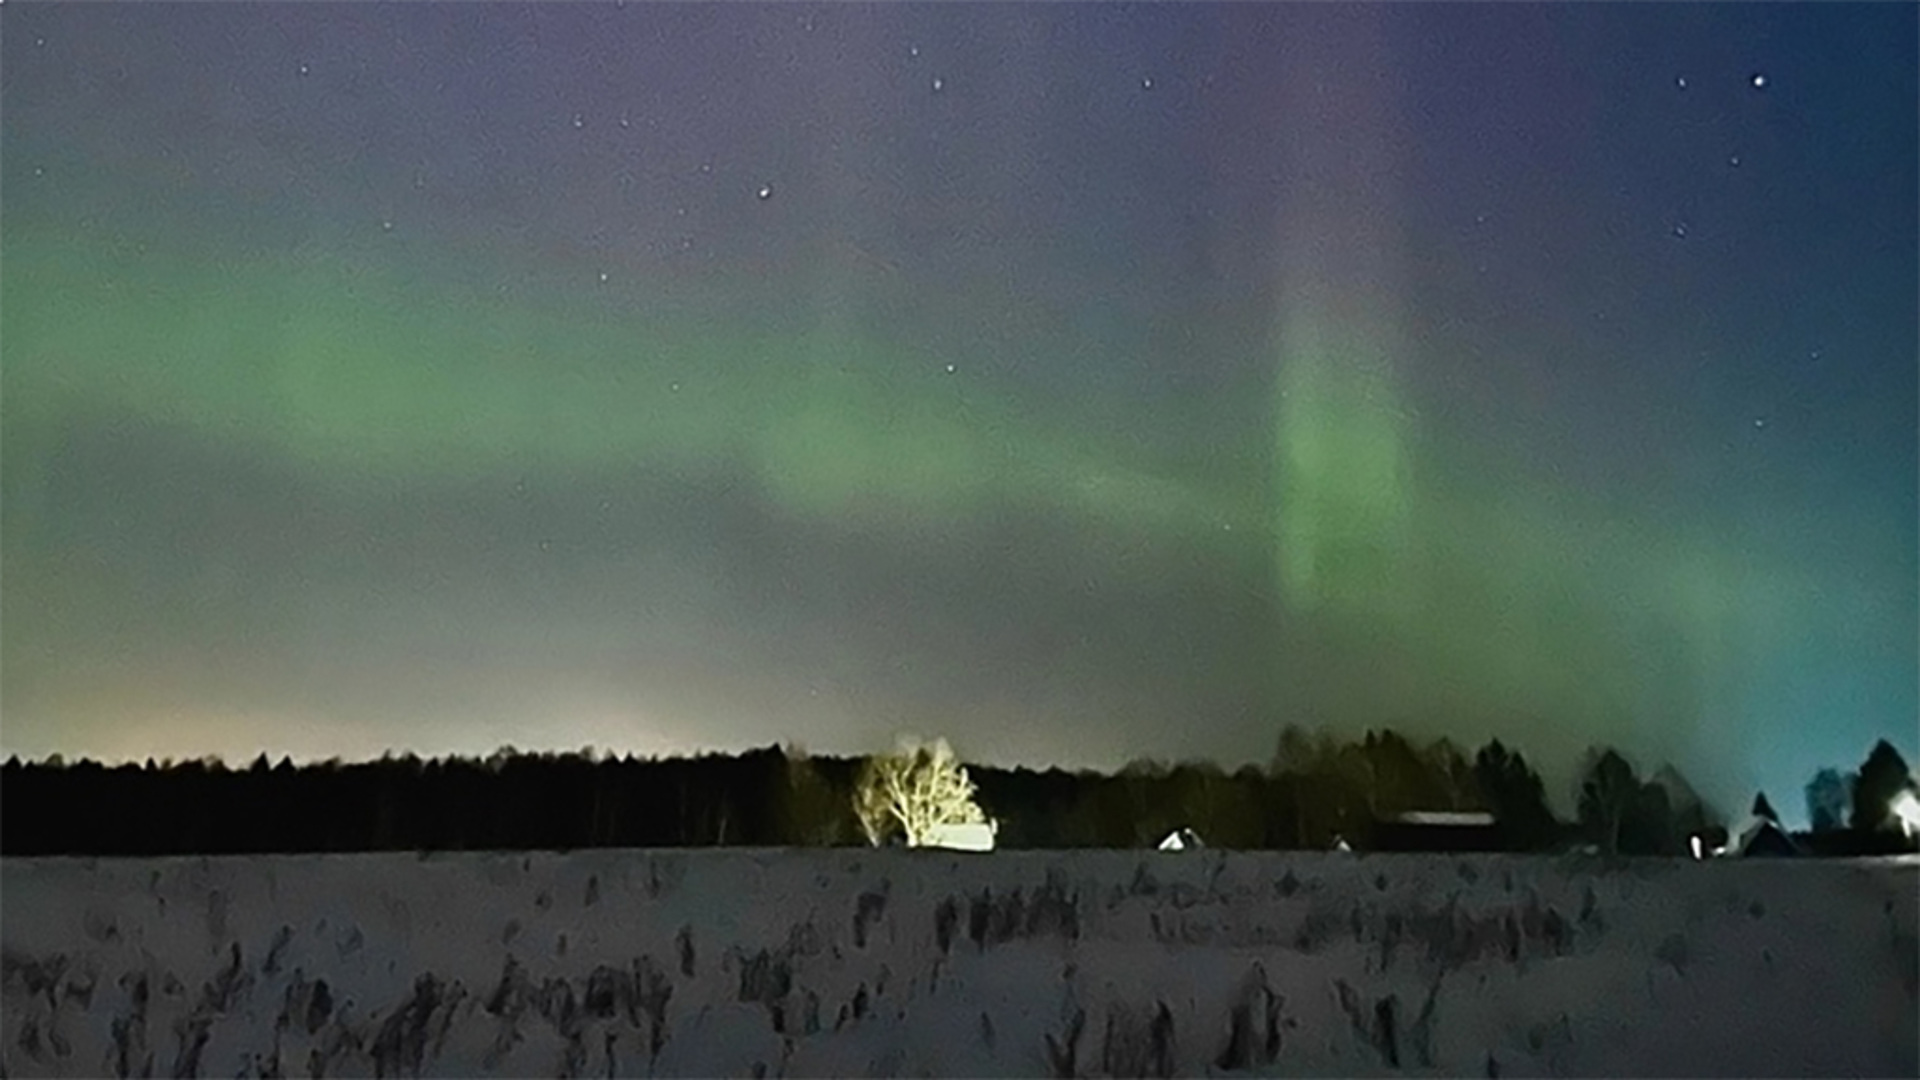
<box><xmin>0</xmin><ymin>728</ymin><xmax>1905</xmax><ymax>855</ymax></box>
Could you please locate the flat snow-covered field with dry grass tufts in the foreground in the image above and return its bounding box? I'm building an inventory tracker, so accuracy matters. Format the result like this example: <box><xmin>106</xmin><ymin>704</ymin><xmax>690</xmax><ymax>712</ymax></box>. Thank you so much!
<box><xmin>0</xmin><ymin>849</ymin><xmax>1920</xmax><ymax>1076</ymax></box>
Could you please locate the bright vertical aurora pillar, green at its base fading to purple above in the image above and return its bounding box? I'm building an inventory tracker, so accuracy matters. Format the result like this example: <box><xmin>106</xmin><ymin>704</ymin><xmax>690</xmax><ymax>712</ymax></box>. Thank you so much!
<box><xmin>1271</xmin><ymin>8</ymin><xmax>1417</xmax><ymax>646</ymax></box>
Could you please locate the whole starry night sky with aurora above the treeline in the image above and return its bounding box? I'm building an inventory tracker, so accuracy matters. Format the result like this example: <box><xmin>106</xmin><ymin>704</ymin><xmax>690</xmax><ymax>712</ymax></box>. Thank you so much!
<box><xmin>0</xmin><ymin>2</ymin><xmax>1920</xmax><ymax>819</ymax></box>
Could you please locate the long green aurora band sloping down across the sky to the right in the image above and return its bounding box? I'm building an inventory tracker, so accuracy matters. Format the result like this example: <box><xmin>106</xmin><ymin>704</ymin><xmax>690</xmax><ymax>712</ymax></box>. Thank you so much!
<box><xmin>0</xmin><ymin>143</ymin><xmax>1899</xmax><ymax>803</ymax></box>
